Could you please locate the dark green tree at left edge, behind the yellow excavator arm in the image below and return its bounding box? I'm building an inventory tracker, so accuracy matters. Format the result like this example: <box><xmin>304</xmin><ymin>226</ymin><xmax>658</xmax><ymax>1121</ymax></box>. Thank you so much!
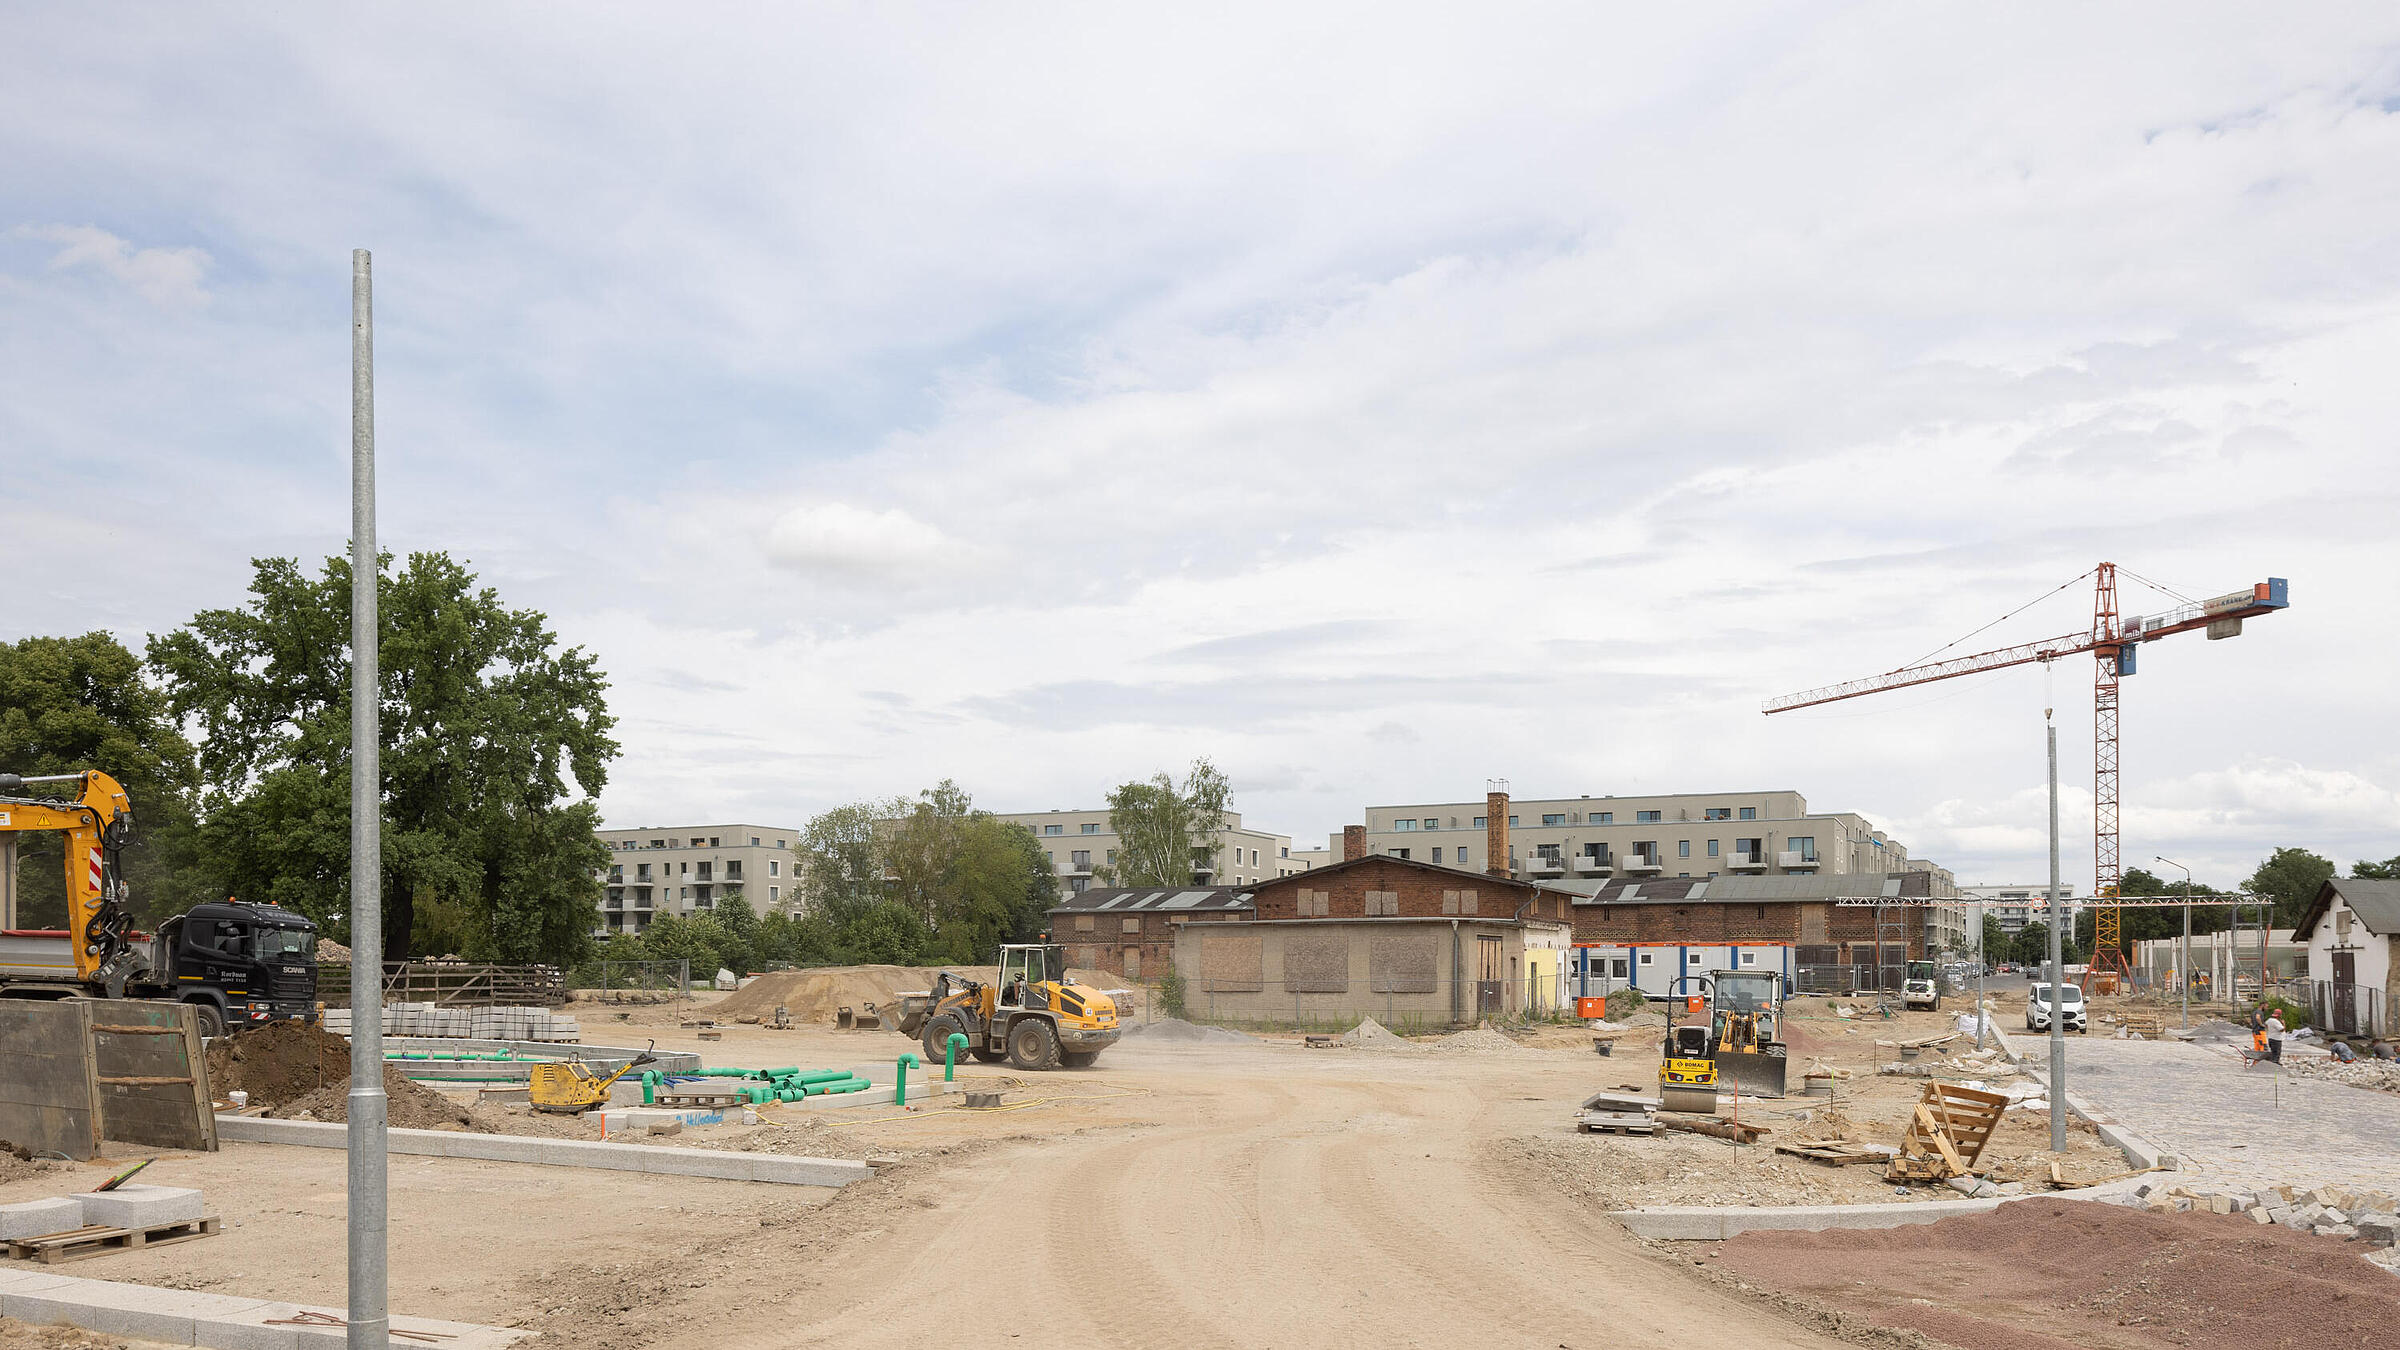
<box><xmin>0</xmin><ymin>632</ymin><xmax>209</xmax><ymax>927</ymax></box>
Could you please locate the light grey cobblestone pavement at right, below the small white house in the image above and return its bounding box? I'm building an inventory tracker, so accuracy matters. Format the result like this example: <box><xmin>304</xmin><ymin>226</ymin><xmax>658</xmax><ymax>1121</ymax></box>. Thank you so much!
<box><xmin>2014</xmin><ymin>1033</ymin><xmax>2400</xmax><ymax>1194</ymax></box>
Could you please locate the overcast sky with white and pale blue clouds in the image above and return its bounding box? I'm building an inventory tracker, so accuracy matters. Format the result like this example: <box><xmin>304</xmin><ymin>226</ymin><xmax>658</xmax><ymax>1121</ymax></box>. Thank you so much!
<box><xmin>0</xmin><ymin>5</ymin><xmax>2400</xmax><ymax>889</ymax></box>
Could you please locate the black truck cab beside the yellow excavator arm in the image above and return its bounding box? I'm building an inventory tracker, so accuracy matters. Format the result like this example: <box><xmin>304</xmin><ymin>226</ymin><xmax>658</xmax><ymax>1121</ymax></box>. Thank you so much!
<box><xmin>149</xmin><ymin>901</ymin><xmax>317</xmax><ymax>1033</ymax></box>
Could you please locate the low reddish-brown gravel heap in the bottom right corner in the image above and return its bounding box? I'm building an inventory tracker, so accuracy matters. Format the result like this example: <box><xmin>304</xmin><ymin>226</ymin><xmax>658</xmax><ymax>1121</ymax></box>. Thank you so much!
<box><xmin>1711</xmin><ymin>1201</ymin><xmax>2400</xmax><ymax>1350</ymax></box>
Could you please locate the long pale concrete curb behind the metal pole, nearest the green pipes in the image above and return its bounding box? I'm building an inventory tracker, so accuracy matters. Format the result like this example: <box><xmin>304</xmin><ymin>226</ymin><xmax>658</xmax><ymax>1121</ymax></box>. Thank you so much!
<box><xmin>216</xmin><ymin>1117</ymin><xmax>874</xmax><ymax>1187</ymax></box>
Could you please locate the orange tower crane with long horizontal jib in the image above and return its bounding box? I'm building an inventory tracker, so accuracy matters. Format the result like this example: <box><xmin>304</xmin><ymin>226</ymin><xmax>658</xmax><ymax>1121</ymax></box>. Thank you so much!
<box><xmin>1764</xmin><ymin>562</ymin><xmax>2292</xmax><ymax>968</ymax></box>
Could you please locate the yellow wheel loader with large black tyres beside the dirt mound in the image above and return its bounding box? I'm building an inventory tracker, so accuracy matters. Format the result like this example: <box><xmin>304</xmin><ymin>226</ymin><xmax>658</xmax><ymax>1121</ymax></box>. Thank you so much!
<box><xmin>900</xmin><ymin>944</ymin><xmax>1118</xmax><ymax>1069</ymax></box>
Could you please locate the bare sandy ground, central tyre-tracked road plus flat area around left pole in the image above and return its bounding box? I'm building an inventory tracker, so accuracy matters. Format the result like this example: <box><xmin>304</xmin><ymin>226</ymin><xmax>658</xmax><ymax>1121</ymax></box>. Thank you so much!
<box><xmin>0</xmin><ymin>1011</ymin><xmax>1836</xmax><ymax>1350</ymax></box>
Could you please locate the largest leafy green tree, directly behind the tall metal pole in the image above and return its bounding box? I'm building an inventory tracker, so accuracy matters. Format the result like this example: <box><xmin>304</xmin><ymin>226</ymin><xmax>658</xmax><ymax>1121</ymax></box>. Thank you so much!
<box><xmin>149</xmin><ymin>552</ymin><xmax>617</xmax><ymax>963</ymax></box>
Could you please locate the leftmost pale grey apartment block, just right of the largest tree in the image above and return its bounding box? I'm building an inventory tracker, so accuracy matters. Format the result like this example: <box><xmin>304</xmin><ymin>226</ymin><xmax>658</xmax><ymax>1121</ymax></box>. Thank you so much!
<box><xmin>595</xmin><ymin>824</ymin><xmax>799</xmax><ymax>937</ymax></box>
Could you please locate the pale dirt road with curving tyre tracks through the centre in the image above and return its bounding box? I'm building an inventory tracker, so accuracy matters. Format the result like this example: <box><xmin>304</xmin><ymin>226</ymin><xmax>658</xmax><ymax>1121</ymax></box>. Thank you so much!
<box><xmin>700</xmin><ymin>1050</ymin><xmax>1834</xmax><ymax>1350</ymax></box>
